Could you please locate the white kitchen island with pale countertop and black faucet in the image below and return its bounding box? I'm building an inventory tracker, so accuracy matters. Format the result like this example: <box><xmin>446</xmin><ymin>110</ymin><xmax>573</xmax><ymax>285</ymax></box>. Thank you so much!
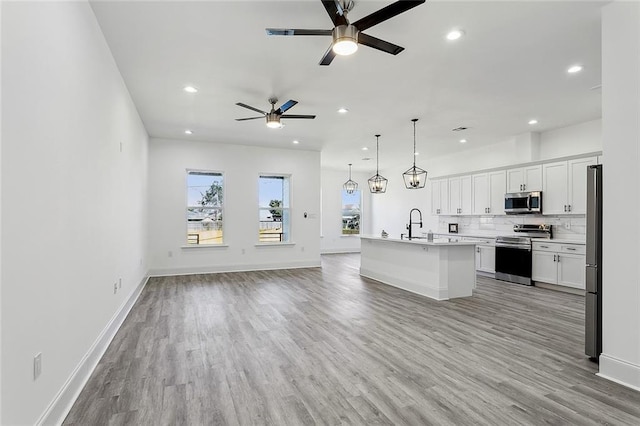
<box><xmin>360</xmin><ymin>236</ymin><xmax>477</xmax><ymax>300</ymax></box>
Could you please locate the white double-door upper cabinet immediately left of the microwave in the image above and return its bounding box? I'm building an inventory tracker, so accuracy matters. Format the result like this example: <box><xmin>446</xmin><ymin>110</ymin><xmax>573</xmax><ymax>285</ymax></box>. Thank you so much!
<box><xmin>471</xmin><ymin>170</ymin><xmax>507</xmax><ymax>215</ymax></box>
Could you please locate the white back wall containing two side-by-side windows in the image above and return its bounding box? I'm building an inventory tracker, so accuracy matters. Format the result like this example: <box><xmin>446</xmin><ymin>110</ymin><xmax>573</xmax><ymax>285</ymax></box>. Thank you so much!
<box><xmin>149</xmin><ymin>139</ymin><xmax>320</xmax><ymax>275</ymax></box>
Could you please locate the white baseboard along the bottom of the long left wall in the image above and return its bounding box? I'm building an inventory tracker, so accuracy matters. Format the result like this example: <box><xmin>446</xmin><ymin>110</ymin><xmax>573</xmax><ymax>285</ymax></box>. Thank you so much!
<box><xmin>35</xmin><ymin>275</ymin><xmax>149</xmax><ymax>426</ymax></box>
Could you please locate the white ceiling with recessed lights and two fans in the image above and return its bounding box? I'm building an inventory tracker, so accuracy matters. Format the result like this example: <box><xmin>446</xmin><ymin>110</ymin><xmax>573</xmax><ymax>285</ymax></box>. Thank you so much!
<box><xmin>92</xmin><ymin>0</ymin><xmax>606</xmax><ymax>171</ymax></box>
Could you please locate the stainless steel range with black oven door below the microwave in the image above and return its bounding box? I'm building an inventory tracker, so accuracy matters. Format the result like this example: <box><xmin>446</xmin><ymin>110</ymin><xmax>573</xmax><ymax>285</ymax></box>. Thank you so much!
<box><xmin>495</xmin><ymin>225</ymin><xmax>551</xmax><ymax>285</ymax></box>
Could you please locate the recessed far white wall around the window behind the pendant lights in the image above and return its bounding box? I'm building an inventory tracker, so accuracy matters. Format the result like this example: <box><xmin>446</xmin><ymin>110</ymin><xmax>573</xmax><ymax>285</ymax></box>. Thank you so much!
<box><xmin>320</xmin><ymin>167</ymin><xmax>371</xmax><ymax>253</ymax></box>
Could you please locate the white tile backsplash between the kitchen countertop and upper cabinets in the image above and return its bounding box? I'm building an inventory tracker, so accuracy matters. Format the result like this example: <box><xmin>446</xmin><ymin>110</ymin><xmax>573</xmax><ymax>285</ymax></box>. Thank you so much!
<box><xmin>437</xmin><ymin>215</ymin><xmax>586</xmax><ymax>241</ymax></box>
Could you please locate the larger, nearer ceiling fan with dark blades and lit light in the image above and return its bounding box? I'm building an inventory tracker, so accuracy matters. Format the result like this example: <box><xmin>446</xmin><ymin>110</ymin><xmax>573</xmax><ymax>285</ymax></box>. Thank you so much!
<box><xmin>266</xmin><ymin>0</ymin><xmax>425</xmax><ymax>65</ymax></box>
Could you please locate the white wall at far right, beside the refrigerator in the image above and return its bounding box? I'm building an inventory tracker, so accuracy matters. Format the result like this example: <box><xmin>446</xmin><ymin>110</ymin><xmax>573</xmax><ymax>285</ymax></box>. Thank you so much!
<box><xmin>600</xmin><ymin>1</ymin><xmax>640</xmax><ymax>390</ymax></box>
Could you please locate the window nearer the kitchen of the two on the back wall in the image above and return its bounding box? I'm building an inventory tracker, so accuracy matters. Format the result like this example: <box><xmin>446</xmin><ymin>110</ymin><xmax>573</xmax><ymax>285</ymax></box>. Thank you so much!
<box><xmin>258</xmin><ymin>176</ymin><xmax>291</xmax><ymax>243</ymax></box>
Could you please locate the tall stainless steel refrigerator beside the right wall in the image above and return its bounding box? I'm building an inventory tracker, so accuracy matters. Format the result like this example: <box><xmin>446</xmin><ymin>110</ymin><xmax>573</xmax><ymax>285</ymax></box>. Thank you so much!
<box><xmin>585</xmin><ymin>165</ymin><xmax>602</xmax><ymax>361</ymax></box>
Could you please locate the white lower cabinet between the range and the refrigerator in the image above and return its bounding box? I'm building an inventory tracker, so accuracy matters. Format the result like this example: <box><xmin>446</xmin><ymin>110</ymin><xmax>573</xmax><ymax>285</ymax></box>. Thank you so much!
<box><xmin>531</xmin><ymin>242</ymin><xmax>585</xmax><ymax>290</ymax></box>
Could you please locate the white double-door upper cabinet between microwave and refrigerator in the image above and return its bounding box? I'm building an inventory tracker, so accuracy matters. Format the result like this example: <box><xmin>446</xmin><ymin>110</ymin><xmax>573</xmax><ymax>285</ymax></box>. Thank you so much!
<box><xmin>542</xmin><ymin>157</ymin><xmax>597</xmax><ymax>214</ymax></box>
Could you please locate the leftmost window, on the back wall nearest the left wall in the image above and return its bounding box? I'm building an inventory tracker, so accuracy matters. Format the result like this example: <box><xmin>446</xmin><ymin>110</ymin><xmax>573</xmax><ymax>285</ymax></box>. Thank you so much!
<box><xmin>187</xmin><ymin>171</ymin><xmax>224</xmax><ymax>245</ymax></box>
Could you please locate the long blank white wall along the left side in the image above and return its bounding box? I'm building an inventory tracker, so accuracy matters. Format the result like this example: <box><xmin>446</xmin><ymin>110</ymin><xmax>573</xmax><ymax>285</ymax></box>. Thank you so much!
<box><xmin>0</xmin><ymin>2</ymin><xmax>147</xmax><ymax>425</ymax></box>
